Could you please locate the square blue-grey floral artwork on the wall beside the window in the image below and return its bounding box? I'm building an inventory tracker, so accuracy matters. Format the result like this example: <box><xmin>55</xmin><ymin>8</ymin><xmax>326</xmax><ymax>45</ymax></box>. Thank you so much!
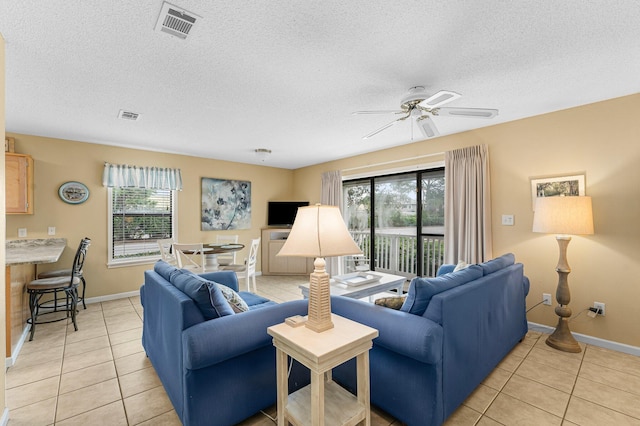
<box><xmin>201</xmin><ymin>178</ymin><xmax>251</xmax><ymax>231</ymax></box>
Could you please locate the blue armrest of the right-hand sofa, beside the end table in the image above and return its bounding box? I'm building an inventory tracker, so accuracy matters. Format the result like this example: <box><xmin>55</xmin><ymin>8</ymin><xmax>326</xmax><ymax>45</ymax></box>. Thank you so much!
<box><xmin>331</xmin><ymin>296</ymin><xmax>442</xmax><ymax>364</ymax></box>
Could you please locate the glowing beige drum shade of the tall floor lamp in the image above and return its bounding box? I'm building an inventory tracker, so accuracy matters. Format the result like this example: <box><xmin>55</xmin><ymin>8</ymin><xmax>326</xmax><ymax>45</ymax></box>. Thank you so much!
<box><xmin>533</xmin><ymin>197</ymin><xmax>593</xmax><ymax>235</ymax></box>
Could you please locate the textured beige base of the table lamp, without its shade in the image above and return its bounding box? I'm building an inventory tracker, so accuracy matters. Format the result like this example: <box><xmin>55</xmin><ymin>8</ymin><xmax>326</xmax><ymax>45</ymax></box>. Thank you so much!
<box><xmin>304</xmin><ymin>257</ymin><xmax>333</xmax><ymax>333</ymax></box>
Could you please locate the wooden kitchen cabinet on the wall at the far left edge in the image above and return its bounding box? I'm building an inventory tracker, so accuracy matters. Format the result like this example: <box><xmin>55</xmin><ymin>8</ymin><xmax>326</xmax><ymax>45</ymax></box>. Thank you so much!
<box><xmin>4</xmin><ymin>152</ymin><xmax>33</xmax><ymax>214</ymax></box>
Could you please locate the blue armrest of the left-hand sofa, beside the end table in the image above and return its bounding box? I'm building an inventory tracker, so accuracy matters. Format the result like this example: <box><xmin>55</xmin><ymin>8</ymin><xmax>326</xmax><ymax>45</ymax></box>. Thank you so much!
<box><xmin>182</xmin><ymin>300</ymin><xmax>308</xmax><ymax>370</ymax></box>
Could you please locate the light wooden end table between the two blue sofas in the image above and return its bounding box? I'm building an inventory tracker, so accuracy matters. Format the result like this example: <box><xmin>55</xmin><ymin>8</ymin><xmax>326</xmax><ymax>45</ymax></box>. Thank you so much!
<box><xmin>267</xmin><ymin>315</ymin><xmax>378</xmax><ymax>426</ymax></box>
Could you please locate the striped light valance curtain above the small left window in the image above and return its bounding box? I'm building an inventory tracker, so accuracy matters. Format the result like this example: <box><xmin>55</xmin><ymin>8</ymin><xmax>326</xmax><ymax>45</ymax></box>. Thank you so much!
<box><xmin>102</xmin><ymin>163</ymin><xmax>182</xmax><ymax>191</ymax></box>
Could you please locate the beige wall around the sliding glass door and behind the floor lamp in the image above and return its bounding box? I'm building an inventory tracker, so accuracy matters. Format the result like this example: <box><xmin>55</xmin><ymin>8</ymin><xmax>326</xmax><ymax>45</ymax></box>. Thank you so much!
<box><xmin>293</xmin><ymin>94</ymin><xmax>640</xmax><ymax>346</ymax></box>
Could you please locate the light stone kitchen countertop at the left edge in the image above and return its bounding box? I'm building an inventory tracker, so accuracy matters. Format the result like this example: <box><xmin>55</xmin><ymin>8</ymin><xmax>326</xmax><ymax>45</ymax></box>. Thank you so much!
<box><xmin>5</xmin><ymin>238</ymin><xmax>67</xmax><ymax>266</ymax></box>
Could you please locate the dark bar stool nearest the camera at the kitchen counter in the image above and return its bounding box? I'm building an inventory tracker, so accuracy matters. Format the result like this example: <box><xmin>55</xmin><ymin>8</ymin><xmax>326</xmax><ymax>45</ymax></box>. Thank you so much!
<box><xmin>27</xmin><ymin>238</ymin><xmax>91</xmax><ymax>341</ymax></box>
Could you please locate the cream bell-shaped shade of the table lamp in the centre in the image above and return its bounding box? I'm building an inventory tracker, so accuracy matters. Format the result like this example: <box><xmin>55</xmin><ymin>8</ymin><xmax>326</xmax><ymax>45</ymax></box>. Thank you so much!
<box><xmin>277</xmin><ymin>204</ymin><xmax>362</xmax><ymax>257</ymax></box>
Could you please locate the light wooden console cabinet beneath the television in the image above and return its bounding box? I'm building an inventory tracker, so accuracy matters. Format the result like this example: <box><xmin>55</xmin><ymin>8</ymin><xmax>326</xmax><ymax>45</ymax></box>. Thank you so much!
<box><xmin>262</xmin><ymin>228</ymin><xmax>313</xmax><ymax>275</ymax></box>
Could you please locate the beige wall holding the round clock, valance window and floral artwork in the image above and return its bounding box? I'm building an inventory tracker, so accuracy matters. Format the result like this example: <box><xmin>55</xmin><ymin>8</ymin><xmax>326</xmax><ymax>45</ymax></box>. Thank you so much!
<box><xmin>3</xmin><ymin>134</ymin><xmax>293</xmax><ymax>298</ymax></box>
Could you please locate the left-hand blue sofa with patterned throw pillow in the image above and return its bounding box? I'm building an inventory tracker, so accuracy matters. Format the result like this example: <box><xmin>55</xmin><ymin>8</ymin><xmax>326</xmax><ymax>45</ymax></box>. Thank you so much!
<box><xmin>140</xmin><ymin>261</ymin><xmax>309</xmax><ymax>426</ymax></box>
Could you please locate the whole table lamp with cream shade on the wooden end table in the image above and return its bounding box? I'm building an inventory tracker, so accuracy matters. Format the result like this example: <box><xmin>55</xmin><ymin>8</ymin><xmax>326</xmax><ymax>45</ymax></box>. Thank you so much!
<box><xmin>277</xmin><ymin>204</ymin><xmax>362</xmax><ymax>333</ymax></box>
